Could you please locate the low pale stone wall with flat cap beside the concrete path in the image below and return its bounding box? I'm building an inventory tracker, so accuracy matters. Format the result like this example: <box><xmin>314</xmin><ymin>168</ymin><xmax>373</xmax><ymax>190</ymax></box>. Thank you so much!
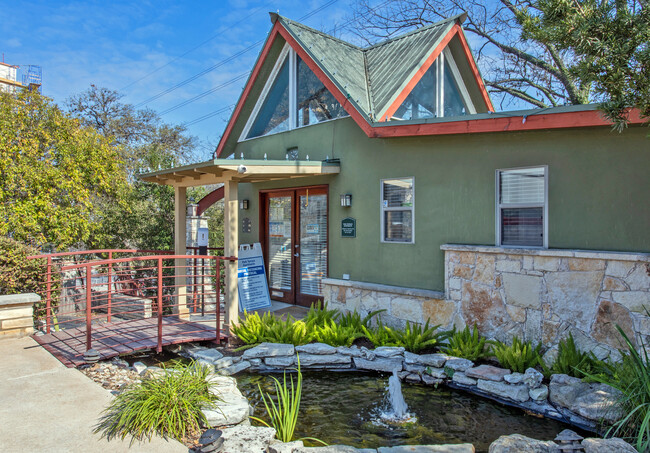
<box><xmin>0</xmin><ymin>293</ymin><xmax>41</xmax><ymax>338</ymax></box>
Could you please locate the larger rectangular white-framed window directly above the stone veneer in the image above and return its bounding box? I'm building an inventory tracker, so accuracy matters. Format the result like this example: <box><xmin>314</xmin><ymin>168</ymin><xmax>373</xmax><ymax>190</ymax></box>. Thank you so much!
<box><xmin>496</xmin><ymin>166</ymin><xmax>548</xmax><ymax>248</ymax></box>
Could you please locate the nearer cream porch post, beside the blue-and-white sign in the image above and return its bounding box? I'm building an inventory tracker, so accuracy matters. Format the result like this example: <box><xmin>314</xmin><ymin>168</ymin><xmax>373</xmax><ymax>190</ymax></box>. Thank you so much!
<box><xmin>223</xmin><ymin>180</ymin><xmax>239</xmax><ymax>334</ymax></box>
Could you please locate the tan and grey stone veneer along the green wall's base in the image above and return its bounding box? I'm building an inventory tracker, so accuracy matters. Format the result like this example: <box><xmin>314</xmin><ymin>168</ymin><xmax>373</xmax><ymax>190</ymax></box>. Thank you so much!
<box><xmin>323</xmin><ymin>245</ymin><xmax>650</xmax><ymax>359</ymax></box>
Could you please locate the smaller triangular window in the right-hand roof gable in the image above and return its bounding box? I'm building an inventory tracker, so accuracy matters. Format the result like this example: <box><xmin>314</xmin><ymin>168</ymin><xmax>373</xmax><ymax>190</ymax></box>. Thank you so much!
<box><xmin>392</xmin><ymin>52</ymin><xmax>476</xmax><ymax>120</ymax></box>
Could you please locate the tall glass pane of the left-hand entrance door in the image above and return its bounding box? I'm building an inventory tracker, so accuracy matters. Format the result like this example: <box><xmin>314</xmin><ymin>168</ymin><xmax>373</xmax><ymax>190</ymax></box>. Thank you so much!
<box><xmin>268</xmin><ymin>196</ymin><xmax>292</xmax><ymax>291</ymax></box>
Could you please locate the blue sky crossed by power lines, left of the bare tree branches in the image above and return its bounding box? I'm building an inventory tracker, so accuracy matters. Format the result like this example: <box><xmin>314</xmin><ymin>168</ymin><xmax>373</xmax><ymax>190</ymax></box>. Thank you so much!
<box><xmin>0</xmin><ymin>0</ymin><xmax>351</xmax><ymax>159</ymax></box>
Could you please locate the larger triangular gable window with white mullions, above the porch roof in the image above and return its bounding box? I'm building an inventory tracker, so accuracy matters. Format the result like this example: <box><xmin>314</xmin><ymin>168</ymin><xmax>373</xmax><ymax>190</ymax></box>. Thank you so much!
<box><xmin>239</xmin><ymin>44</ymin><xmax>348</xmax><ymax>141</ymax></box>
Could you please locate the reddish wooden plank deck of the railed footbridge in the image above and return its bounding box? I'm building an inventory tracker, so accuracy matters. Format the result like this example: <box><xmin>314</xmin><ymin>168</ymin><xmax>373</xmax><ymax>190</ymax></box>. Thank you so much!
<box><xmin>34</xmin><ymin>317</ymin><xmax>226</xmax><ymax>368</ymax></box>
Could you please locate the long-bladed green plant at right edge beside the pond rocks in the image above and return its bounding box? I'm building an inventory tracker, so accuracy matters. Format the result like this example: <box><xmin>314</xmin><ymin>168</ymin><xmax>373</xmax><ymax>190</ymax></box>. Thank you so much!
<box><xmin>587</xmin><ymin>326</ymin><xmax>650</xmax><ymax>452</ymax></box>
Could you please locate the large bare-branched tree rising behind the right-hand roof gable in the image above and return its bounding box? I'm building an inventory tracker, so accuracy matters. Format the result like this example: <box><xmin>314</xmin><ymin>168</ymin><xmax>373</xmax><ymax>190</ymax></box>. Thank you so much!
<box><xmin>348</xmin><ymin>0</ymin><xmax>591</xmax><ymax>109</ymax></box>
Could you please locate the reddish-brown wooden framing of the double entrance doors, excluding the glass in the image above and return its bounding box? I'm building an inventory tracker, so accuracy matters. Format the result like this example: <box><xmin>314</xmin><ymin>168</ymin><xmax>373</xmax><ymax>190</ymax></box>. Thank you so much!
<box><xmin>258</xmin><ymin>184</ymin><xmax>330</xmax><ymax>306</ymax></box>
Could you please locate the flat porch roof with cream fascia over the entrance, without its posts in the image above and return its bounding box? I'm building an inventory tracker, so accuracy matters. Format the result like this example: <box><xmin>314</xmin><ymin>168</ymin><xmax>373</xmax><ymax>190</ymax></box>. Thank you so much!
<box><xmin>139</xmin><ymin>159</ymin><xmax>341</xmax><ymax>187</ymax></box>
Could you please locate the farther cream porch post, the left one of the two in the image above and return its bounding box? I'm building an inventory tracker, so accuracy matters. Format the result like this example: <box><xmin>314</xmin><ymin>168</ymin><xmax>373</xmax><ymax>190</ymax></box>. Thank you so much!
<box><xmin>174</xmin><ymin>187</ymin><xmax>190</xmax><ymax>319</ymax></box>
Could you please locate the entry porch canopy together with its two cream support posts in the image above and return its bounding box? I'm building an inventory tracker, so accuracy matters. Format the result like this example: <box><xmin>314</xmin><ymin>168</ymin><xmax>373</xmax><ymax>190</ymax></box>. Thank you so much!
<box><xmin>140</xmin><ymin>159</ymin><xmax>340</xmax><ymax>334</ymax></box>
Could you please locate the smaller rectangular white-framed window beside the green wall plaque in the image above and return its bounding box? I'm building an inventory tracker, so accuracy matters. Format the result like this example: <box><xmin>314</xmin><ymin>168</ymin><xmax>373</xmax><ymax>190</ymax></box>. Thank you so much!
<box><xmin>381</xmin><ymin>177</ymin><xmax>415</xmax><ymax>244</ymax></box>
